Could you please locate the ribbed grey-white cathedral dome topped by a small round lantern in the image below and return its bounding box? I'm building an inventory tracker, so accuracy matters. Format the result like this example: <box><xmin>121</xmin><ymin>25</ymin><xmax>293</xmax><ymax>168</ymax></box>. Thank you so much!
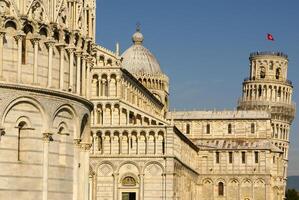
<box><xmin>122</xmin><ymin>29</ymin><xmax>163</xmax><ymax>75</ymax></box>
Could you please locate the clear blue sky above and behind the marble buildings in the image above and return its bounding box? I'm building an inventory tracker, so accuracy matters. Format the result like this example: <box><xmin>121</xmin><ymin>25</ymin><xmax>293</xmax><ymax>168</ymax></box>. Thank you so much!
<box><xmin>97</xmin><ymin>0</ymin><xmax>299</xmax><ymax>175</ymax></box>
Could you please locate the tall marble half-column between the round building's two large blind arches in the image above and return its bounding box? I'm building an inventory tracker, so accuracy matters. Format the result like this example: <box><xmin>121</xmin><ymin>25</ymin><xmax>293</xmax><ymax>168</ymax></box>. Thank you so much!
<box><xmin>43</xmin><ymin>133</ymin><xmax>52</xmax><ymax>200</ymax></box>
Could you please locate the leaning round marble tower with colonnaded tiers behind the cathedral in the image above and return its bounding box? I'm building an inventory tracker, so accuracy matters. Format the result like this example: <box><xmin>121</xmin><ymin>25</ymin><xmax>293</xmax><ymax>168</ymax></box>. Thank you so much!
<box><xmin>238</xmin><ymin>52</ymin><xmax>295</xmax><ymax>194</ymax></box>
